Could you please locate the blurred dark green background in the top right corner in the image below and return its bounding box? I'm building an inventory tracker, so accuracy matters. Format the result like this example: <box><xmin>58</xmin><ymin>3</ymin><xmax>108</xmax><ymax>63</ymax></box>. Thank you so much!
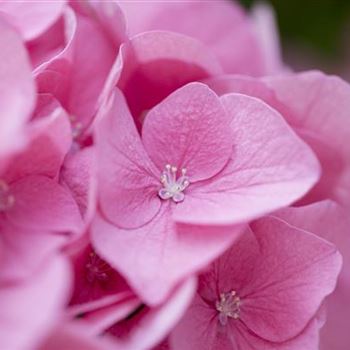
<box><xmin>240</xmin><ymin>0</ymin><xmax>350</xmax><ymax>78</ymax></box>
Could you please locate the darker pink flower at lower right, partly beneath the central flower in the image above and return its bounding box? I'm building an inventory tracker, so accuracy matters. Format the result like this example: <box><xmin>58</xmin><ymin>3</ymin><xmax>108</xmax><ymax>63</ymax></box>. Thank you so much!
<box><xmin>171</xmin><ymin>217</ymin><xmax>341</xmax><ymax>350</ymax></box>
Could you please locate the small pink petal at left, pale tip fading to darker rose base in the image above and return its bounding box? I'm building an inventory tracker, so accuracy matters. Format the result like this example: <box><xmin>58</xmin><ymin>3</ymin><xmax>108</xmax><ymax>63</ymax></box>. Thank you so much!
<box><xmin>4</xmin><ymin>107</ymin><xmax>72</xmax><ymax>183</ymax></box>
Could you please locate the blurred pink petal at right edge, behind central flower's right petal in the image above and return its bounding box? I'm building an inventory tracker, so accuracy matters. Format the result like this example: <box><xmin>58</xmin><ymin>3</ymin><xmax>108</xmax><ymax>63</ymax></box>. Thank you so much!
<box><xmin>265</xmin><ymin>72</ymin><xmax>350</xmax><ymax>206</ymax></box>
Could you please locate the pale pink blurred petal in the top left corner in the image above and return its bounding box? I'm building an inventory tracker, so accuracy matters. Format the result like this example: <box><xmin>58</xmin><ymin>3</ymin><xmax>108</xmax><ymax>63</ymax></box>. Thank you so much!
<box><xmin>0</xmin><ymin>0</ymin><xmax>66</xmax><ymax>40</ymax></box>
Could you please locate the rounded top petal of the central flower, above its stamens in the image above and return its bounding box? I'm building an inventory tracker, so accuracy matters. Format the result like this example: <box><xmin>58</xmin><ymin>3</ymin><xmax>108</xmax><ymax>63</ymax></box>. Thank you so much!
<box><xmin>142</xmin><ymin>83</ymin><xmax>232</xmax><ymax>183</ymax></box>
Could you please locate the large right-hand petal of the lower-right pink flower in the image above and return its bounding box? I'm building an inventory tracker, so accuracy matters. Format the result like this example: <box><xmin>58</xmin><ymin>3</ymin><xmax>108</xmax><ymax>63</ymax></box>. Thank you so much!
<box><xmin>241</xmin><ymin>218</ymin><xmax>341</xmax><ymax>342</ymax></box>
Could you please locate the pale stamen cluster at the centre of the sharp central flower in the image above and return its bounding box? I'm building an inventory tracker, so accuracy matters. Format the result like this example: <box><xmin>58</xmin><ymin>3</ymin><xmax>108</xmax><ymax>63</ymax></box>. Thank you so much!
<box><xmin>158</xmin><ymin>164</ymin><xmax>190</xmax><ymax>203</ymax></box>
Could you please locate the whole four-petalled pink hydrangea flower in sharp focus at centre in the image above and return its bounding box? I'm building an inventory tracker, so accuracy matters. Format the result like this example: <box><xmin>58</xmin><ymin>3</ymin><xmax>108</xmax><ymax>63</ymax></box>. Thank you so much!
<box><xmin>92</xmin><ymin>83</ymin><xmax>318</xmax><ymax>304</ymax></box>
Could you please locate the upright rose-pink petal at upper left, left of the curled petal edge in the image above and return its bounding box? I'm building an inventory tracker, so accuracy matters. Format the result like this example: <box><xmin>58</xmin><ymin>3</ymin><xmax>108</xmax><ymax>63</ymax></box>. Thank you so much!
<box><xmin>67</xmin><ymin>7</ymin><xmax>123</xmax><ymax>132</ymax></box>
